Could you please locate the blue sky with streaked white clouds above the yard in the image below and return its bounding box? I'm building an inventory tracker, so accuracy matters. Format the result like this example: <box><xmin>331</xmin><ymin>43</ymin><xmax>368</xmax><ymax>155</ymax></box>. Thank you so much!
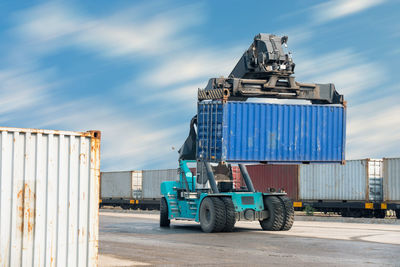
<box><xmin>0</xmin><ymin>0</ymin><xmax>400</xmax><ymax>171</ymax></box>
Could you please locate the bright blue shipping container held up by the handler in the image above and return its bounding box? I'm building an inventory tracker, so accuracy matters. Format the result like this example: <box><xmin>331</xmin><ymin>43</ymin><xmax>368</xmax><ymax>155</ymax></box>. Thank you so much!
<box><xmin>197</xmin><ymin>101</ymin><xmax>346</xmax><ymax>163</ymax></box>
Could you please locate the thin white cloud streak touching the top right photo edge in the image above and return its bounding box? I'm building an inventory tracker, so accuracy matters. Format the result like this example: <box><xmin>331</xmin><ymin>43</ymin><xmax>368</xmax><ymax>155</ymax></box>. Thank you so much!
<box><xmin>312</xmin><ymin>0</ymin><xmax>385</xmax><ymax>23</ymax></box>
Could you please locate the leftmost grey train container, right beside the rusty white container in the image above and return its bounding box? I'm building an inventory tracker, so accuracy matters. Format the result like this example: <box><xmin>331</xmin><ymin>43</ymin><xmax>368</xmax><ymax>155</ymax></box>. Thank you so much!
<box><xmin>100</xmin><ymin>171</ymin><xmax>133</xmax><ymax>198</ymax></box>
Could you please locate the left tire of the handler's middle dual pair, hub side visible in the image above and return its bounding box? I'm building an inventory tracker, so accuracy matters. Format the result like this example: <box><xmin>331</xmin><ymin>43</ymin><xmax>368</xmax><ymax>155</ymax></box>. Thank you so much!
<box><xmin>200</xmin><ymin>197</ymin><xmax>226</xmax><ymax>233</ymax></box>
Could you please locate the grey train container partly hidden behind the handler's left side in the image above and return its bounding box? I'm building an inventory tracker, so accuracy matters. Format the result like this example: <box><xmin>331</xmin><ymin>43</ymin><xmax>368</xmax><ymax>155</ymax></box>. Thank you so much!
<box><xmin>142</xmin><ymin>169</ymin><xmax>179</xmax><ymax>199</ymax></box>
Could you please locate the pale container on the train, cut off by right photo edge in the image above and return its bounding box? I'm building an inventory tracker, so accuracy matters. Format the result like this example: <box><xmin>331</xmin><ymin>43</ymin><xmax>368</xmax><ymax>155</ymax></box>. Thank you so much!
<box><xmin>383</xmin><ymin>158</ymin><xmax>400</xmax><ymax>203</ymax></box>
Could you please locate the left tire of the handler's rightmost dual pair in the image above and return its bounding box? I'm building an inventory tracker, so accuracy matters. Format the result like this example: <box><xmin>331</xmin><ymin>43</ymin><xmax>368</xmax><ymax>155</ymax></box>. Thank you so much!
<box><xmin>260</xmin><ymin>196</ymin><xmax>284</xmax><ymax>231</ymax></box>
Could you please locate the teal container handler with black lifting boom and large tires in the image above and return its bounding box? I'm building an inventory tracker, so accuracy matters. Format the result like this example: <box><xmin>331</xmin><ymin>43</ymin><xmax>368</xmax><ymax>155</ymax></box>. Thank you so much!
<box><xmin>160</xmin><ymin>34</ymin><xmax>345</xmax><ymax>233</ymax></box>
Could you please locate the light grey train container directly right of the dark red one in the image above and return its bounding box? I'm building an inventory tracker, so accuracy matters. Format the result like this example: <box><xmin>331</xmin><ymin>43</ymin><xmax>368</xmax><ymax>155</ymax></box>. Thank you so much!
<box><xmin>299</xmin><ymin>159</ymin><xmax>369</xmax><ymax>201</ymax></box>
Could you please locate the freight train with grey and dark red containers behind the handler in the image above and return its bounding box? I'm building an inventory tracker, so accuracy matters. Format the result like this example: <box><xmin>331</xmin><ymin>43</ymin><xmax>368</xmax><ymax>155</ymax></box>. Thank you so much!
<box><xmin>100</xmin><ymin>158</ymin><xmax>400</xmax><ymax>219</ymax></box>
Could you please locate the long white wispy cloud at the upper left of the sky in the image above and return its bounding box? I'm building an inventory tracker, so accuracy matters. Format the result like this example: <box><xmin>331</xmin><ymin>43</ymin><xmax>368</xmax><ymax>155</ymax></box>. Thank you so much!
<box><xmin>18</xmin><ymin>3</ymin><xmax>201</xmax><ymax>57</ymax></box>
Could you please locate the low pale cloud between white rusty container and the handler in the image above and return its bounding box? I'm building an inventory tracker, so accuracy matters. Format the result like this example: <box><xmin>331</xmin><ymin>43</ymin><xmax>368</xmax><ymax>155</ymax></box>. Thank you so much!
<box><xmin>37</xmin><ymin>98</ymin><xmax>187</xmax><ymax>170</ymax></box>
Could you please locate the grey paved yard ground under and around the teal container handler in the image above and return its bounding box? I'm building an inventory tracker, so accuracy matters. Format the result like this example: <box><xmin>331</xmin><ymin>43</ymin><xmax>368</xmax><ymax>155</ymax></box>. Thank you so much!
<box><xmin>99</xmin><ymin>211</ymin><xmax>400</xmax><ymax>266</ymax></box>
